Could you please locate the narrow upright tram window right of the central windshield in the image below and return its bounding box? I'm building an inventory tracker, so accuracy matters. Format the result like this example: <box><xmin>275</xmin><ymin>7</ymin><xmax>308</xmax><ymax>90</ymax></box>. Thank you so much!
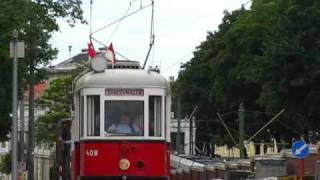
<box><xmin>149</xmin><ymin>96</ymin><xmax>162</xmax><ymax>136</ymax></box>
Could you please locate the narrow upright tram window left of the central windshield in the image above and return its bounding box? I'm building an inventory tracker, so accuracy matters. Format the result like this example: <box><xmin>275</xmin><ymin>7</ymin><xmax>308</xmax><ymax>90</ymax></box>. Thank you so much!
<box><xmin>87</xmin><ymin>95</ymin><xmax>100</xmax><ymax>136</ymax></box>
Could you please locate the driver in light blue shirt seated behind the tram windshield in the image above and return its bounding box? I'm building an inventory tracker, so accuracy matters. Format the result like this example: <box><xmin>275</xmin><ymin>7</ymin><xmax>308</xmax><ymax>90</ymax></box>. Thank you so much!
<box><xmin>108</xmin><ymin>113</ymin><xmax>141</xmax><ymax>135</ymax></box>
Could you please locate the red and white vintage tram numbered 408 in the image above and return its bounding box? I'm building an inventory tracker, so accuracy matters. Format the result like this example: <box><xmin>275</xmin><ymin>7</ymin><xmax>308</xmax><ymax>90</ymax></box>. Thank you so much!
<box><xmin>72</xmin><ymin>59</ymin><xmax>171</xmax><ymax>180</ymax></box>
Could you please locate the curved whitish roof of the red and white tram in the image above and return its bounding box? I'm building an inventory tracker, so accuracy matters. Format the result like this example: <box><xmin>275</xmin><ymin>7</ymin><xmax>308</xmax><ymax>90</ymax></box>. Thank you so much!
<box><xmin>75</xmin><ymin>69</ymin><xmax>170</xmax><ymax>91</ymax></box>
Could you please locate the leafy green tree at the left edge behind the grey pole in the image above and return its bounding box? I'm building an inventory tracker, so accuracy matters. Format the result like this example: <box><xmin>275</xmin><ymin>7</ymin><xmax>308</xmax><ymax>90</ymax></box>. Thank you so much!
<box><xmin>0</xmin><ymin>0</ymin><xmax>85</xmax><ymax>141</ymax></box>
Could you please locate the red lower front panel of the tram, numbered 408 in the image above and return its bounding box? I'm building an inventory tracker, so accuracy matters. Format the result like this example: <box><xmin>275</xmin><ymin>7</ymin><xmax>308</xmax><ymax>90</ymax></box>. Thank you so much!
<box><xmin>79</xmin><ymin>141</ymin><xmax>170</xmax><ymax>178</ymax></box>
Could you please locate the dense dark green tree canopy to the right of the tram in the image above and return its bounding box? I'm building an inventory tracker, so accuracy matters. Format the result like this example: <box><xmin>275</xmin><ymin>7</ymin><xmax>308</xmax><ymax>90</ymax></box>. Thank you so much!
<box><xmin>174</xmin><ymin>0</ymin><xmax>320</xmax><ymax>146</ymax></box>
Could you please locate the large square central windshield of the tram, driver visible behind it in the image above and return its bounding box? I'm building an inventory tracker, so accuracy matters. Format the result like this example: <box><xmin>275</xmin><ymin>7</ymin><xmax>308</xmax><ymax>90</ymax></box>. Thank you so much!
<box><xmin>105</xmin><ymin>101</ymin><xmax>144</xmax><ymax>136</ymax></box>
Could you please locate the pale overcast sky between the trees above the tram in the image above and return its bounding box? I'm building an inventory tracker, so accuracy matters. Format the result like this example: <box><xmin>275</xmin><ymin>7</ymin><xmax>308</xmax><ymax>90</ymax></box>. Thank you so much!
<box><xmin>51</xmin><ymin>0</ymin><xmax>247</xmax><ymax>77</ymax></box>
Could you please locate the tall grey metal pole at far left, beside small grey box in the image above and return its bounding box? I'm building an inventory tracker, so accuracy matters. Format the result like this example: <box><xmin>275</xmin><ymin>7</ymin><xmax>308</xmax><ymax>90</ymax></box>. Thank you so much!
<box><xmin>11</xmin><ymin>30</ymin><xmax>18</xmax><ymax>180</ymax></box>
